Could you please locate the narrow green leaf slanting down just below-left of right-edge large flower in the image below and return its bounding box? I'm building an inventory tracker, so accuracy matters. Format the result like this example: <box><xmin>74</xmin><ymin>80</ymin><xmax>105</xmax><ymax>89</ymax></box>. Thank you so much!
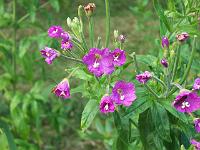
<box><xmin>161</xmin><ymin>101</ymin><xmax>188</xmax><ymax>123</ymax></box>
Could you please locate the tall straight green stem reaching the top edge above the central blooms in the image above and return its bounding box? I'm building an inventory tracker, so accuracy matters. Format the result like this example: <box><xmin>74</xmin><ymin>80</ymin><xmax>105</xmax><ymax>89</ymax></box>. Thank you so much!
<box><xmin>105</xmin><ymin>0</ymin><xmax>110</xmax><ymax>47</ymax></box>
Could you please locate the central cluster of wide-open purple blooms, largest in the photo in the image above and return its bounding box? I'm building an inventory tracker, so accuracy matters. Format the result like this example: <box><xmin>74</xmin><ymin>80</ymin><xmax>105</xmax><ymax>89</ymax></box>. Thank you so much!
<box><xmin>82</xmin><ymin>48</ymin><xmax>126</xmax><ymax>77</ymax></box>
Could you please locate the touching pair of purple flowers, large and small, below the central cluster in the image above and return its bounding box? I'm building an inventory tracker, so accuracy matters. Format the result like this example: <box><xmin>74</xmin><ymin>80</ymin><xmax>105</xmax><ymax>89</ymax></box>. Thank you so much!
<box><xmin>100</xmin><ymin>81</ymin><xmax>136</xmax><ymax>113</ymax></box>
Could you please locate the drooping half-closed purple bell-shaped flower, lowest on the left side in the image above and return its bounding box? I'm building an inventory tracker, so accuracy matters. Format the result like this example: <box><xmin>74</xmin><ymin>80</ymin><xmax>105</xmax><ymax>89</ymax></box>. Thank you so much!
<box><xmin>52</xmin><ymin>78</ymin><xmax>70</xmax><ymax>99</ymax></box>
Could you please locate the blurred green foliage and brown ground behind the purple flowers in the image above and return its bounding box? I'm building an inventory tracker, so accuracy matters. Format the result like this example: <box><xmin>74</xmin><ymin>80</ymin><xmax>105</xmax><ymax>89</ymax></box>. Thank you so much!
<box><xmin>0</xmin><ymin>0</ymin><xmax>159</xmax><ymax>150</ymax></box>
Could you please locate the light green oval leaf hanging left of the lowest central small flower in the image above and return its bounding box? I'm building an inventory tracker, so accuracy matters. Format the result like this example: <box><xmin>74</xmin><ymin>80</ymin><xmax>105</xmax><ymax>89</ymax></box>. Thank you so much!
<box><xmin>81</xmin><ymin>100</ymin><xmax>99</xmax><ymax>131</ymax></box>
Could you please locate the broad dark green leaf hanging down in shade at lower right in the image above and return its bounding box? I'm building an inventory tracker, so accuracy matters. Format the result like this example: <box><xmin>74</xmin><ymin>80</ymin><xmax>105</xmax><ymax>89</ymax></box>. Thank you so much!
<box><xmin>151</xmin><ymin>102</ymin><xmax>171</xmax><ymax>142</ymax></box>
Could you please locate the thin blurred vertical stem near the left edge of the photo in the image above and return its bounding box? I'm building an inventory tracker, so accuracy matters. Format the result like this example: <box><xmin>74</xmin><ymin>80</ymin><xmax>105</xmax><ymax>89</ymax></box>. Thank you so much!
<box><xmin>12</xmin><ymin>0</ymin><xmax>17</xmax><ymax>92</ymax></box>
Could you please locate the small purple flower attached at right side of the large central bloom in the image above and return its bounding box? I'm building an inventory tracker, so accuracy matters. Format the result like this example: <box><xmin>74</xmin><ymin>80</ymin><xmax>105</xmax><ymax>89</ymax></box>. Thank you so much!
<box><xmin>111</xmin><ymin>49</ymin><xmax>126</xmax><ymax>66</ymax></box>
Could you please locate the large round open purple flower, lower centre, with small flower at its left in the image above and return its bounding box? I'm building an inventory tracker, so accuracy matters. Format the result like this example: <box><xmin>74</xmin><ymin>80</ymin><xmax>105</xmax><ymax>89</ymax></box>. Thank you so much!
<box><xmin>112</xmin><ymin>81</ymin><xmax>136</xmax><ymax>106</ymax></box>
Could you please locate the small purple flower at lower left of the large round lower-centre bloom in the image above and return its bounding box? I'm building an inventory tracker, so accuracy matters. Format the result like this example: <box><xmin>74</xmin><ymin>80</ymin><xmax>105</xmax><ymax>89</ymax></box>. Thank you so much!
<box><xmin>99</xmin><ymin>95</ymin><xmax>115</xmax><ymax>114</ymax></box>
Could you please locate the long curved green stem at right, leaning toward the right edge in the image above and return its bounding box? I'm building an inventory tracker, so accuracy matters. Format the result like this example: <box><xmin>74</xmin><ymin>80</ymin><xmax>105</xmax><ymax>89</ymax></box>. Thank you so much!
<box><xmin>168</xmin><ymin>36</ymin><xmax>196</xmax><ymax>96</ymax></box>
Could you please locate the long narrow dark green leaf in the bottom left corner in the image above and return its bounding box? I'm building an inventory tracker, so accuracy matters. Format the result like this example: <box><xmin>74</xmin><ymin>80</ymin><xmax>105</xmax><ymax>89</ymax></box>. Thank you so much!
<box><xmin>0</xmin><ymin>120</ymin><xmax>17</xmax><ymax>150</ymax></box>
